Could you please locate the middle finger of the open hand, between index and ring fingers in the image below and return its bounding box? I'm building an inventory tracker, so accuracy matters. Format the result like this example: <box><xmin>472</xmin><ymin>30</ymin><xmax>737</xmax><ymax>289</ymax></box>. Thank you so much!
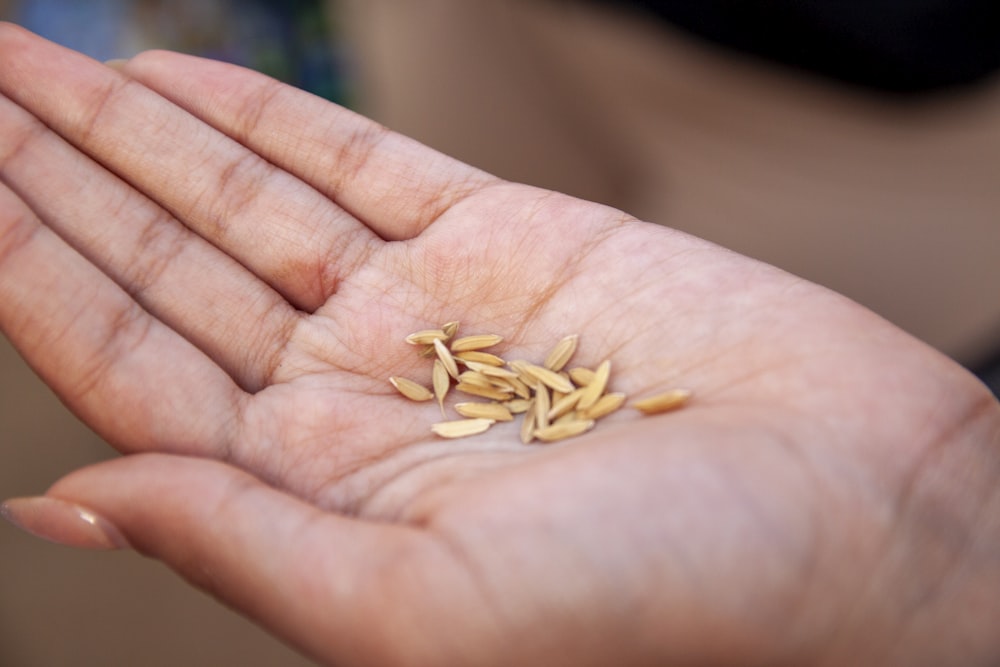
<box><xmin>0</xmin><ymin>91</ymin><xmax>299</xmax><ymax>391</ymax></box>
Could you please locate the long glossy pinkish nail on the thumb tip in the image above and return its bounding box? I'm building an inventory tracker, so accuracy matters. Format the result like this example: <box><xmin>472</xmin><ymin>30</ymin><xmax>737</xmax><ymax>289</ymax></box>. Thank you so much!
<box><xmin>0</xmin><ymin>496</ymin><xmax>129</xmax><ymax>550</ymax></box>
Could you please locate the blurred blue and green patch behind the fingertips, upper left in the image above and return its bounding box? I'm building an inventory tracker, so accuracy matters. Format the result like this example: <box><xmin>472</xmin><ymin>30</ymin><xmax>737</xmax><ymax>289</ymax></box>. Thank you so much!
<box><xmin>0</xmin><ymin>0</ymin><xmax>347</xmax><ymax>104</ymax></box>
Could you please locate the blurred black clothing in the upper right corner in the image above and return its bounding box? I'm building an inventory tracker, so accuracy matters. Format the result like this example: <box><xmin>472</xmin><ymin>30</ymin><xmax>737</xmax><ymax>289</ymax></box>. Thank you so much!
<box><xmin>592</xmin><ymin>0</ymin><xmax>1000</xmax><ymax>93</ymax></box>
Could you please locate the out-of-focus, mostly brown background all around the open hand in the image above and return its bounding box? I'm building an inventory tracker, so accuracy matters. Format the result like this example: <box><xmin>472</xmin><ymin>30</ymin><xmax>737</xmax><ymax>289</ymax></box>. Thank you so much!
<box><xmin>0</xmin><ymin>0</ymin><xmax>1000</xmax><ymax>667</ymax></box>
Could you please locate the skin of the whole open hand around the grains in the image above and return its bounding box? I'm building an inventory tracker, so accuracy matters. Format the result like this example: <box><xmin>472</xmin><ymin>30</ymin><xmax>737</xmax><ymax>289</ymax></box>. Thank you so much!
<box><xmin>0</xmin><ymin>25</ymin><xmax>1000</xmax><ymax>665</ymax></box>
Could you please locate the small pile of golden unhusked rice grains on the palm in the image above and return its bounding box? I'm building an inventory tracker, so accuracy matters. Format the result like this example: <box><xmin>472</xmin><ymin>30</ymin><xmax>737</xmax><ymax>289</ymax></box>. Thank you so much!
<box><xmin>389</xmin><ymin>322</ymin><xmax>691</xmax><ymax>444</ymax></box>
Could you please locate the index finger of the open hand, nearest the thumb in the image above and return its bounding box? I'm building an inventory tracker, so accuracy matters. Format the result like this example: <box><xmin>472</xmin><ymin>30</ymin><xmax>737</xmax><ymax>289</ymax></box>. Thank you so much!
<box><xmin>0</xmin><ymin>184</ymin><xmax>243</xmax><ymax>456</ymax></box>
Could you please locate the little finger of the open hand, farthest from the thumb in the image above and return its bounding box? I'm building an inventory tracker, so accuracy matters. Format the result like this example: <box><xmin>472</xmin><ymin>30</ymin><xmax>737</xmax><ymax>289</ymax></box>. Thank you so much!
<box><xmin>117</xmin><ymin>52</ymin><xmax>498</xmax><ymax>240</ymax></box>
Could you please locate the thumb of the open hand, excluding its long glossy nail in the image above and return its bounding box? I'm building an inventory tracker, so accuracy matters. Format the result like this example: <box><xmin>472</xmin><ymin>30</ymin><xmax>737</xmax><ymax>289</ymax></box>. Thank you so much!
<box><xmin>48</xmin><ymin>454</ymin><xmax>468</xmax><ymax>664</ymax></box>
